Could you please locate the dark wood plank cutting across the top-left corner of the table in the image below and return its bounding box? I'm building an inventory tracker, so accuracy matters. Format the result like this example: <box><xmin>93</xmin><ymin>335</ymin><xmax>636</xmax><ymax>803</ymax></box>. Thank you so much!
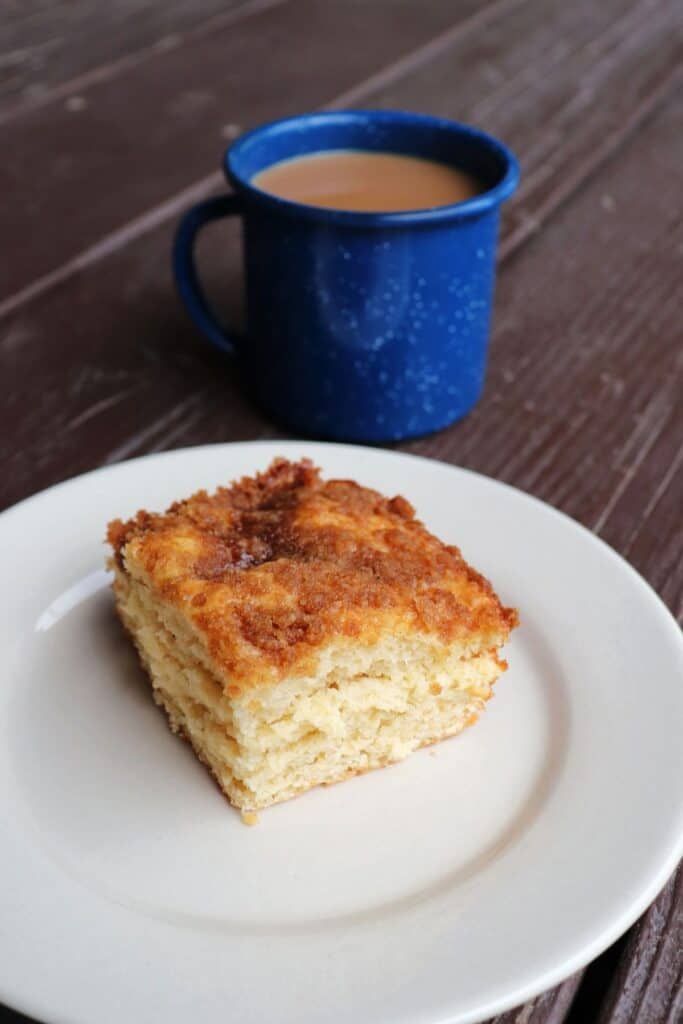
<box><xmin>0</xmin><ymin>0</ymin><xmax>250</xmax><ymax>121</ymax></box>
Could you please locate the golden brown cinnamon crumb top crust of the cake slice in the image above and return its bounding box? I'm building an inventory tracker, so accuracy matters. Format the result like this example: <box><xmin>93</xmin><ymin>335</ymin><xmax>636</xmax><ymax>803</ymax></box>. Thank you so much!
<box><xmin>108</xmin><ymin>459</ymin><xmax>517</xmax><ymax>686</ymax></box>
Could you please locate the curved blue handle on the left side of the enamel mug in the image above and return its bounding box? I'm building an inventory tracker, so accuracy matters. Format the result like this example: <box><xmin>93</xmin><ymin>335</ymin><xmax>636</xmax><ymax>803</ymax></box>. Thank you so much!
<box><xmin>173</xmin><ymin>196</ymin><xmax>242</xmax><ymax>355</ymax></box>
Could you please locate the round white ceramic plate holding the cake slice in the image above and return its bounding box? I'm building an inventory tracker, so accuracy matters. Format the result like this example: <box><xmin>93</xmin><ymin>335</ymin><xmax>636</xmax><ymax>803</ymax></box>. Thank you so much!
<box><xmin>0</xmin><ymin>442</ymin><xmax>683</xmax><ymax>1024</ymax></box>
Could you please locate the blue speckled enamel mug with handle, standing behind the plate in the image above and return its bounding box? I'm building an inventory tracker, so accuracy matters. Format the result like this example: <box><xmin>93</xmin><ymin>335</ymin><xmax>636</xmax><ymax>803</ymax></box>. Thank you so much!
<box><xmin>173</xmin><ymin>111</ymin><xmax>519</xmax><ymax>442</ymax></box>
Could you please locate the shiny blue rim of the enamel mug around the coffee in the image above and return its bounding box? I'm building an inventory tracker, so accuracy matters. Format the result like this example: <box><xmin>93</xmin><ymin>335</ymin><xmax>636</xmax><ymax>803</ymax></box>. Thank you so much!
<box><xmin>223</xmin><ymin>110</ymin><xmax>519</xmax><ymax>227</ymax></box>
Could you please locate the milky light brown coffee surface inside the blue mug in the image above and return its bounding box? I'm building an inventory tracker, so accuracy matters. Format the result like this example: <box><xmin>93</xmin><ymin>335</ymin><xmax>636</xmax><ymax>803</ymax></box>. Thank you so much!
<box><xmin>252</xmin><ymin>150</ymin><xmax>482</xmax><ymax>213</ymax></box>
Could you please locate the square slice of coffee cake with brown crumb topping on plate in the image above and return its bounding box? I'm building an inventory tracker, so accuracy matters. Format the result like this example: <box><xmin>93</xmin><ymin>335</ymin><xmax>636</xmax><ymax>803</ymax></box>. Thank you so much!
<box><xmin>108</xmin><ymin>460</ymin><xmax>517</xmax><ymax>811</ymax></box>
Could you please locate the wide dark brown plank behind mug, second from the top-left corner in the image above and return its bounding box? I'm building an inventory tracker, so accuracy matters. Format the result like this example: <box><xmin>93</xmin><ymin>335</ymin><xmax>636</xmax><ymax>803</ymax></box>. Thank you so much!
<box><xmin>0</xmin><ymin>0</ymin><xmax>485</xmax><ymax>299</ymax></box>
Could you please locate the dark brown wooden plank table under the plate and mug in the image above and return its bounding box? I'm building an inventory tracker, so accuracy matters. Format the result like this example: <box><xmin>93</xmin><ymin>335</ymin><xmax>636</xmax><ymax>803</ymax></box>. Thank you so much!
<box><xmin>0</xmin><ymin>0</ymin><xmax>683</xmax><ymax>1024</ymax></box>
